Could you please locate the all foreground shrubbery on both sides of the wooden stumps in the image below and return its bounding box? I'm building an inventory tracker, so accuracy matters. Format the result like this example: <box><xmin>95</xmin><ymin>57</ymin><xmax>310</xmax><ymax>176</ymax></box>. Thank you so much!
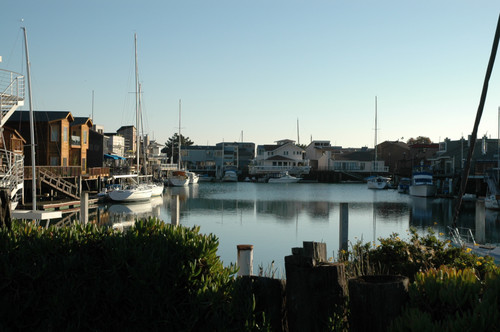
<box><xmin>0</xmin><ymin>218</ymin><xmax>500</xmax><ymax>331</ymax></box>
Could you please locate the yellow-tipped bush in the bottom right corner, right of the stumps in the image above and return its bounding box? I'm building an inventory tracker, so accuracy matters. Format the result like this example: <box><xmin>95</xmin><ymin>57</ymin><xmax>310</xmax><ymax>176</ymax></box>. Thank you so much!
<box><xmin>390</xmin><ymin>266</ymin><xmax>500</xmax><ymax>331</ymax></box>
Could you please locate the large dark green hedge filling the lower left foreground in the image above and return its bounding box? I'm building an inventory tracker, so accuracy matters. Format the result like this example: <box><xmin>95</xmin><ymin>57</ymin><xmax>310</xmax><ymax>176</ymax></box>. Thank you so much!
<box><xmin>0</xmin><ymin>218</ymin><xmax>268</xmax><ymax>331</ymax></box>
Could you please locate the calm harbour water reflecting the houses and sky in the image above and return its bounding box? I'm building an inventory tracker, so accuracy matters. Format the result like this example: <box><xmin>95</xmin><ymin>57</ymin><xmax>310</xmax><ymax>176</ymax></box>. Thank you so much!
<box><xmin>90</xmin><ymin>183</ymin><xmax>500</xmax><ymax>273</ymax></box>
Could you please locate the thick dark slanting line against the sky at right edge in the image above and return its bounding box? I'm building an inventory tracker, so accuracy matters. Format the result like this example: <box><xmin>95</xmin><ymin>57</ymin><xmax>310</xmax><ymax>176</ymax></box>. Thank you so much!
<box><xmin>453</xmin><ymin>15</ymin><xmax>500</xmax><ymax>228</ymax></box>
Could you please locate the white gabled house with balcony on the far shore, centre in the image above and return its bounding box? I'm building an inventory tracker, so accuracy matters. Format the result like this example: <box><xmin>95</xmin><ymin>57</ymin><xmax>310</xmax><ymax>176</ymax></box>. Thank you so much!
<box><xmin>248</xmin><ymin>139</ymin><xmax>310</xmax><ymax>175</ymax></box>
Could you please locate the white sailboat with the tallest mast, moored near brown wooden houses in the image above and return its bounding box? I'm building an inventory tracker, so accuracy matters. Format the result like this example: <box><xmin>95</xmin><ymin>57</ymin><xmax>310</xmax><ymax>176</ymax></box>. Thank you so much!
<box><xmin>109</xmin><ymin>34</ymin><xmax>153</xmax><ymax>202</ymax></box>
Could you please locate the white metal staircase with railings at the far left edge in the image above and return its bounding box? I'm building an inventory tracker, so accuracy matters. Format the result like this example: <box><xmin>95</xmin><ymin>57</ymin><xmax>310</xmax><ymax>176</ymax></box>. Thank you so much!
<box><xmin>0</xmin><ymin>69</ymin><xmax>25</xmax><ymax>209</ymax></box>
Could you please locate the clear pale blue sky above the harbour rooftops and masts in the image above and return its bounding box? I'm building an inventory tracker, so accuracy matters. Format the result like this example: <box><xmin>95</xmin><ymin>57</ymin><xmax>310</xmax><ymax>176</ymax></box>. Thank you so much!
<box><xmin>0</xmin><ymin>0</ymin><xmax>500</xmax><ymax>147</ymax></box>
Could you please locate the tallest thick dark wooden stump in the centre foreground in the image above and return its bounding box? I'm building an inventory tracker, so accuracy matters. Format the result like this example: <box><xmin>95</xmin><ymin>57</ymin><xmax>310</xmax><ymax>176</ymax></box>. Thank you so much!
<box><xmin>285</xmin><ymin>242</ymin><xmax>347</xmax><ymax>332</ymax></box>
